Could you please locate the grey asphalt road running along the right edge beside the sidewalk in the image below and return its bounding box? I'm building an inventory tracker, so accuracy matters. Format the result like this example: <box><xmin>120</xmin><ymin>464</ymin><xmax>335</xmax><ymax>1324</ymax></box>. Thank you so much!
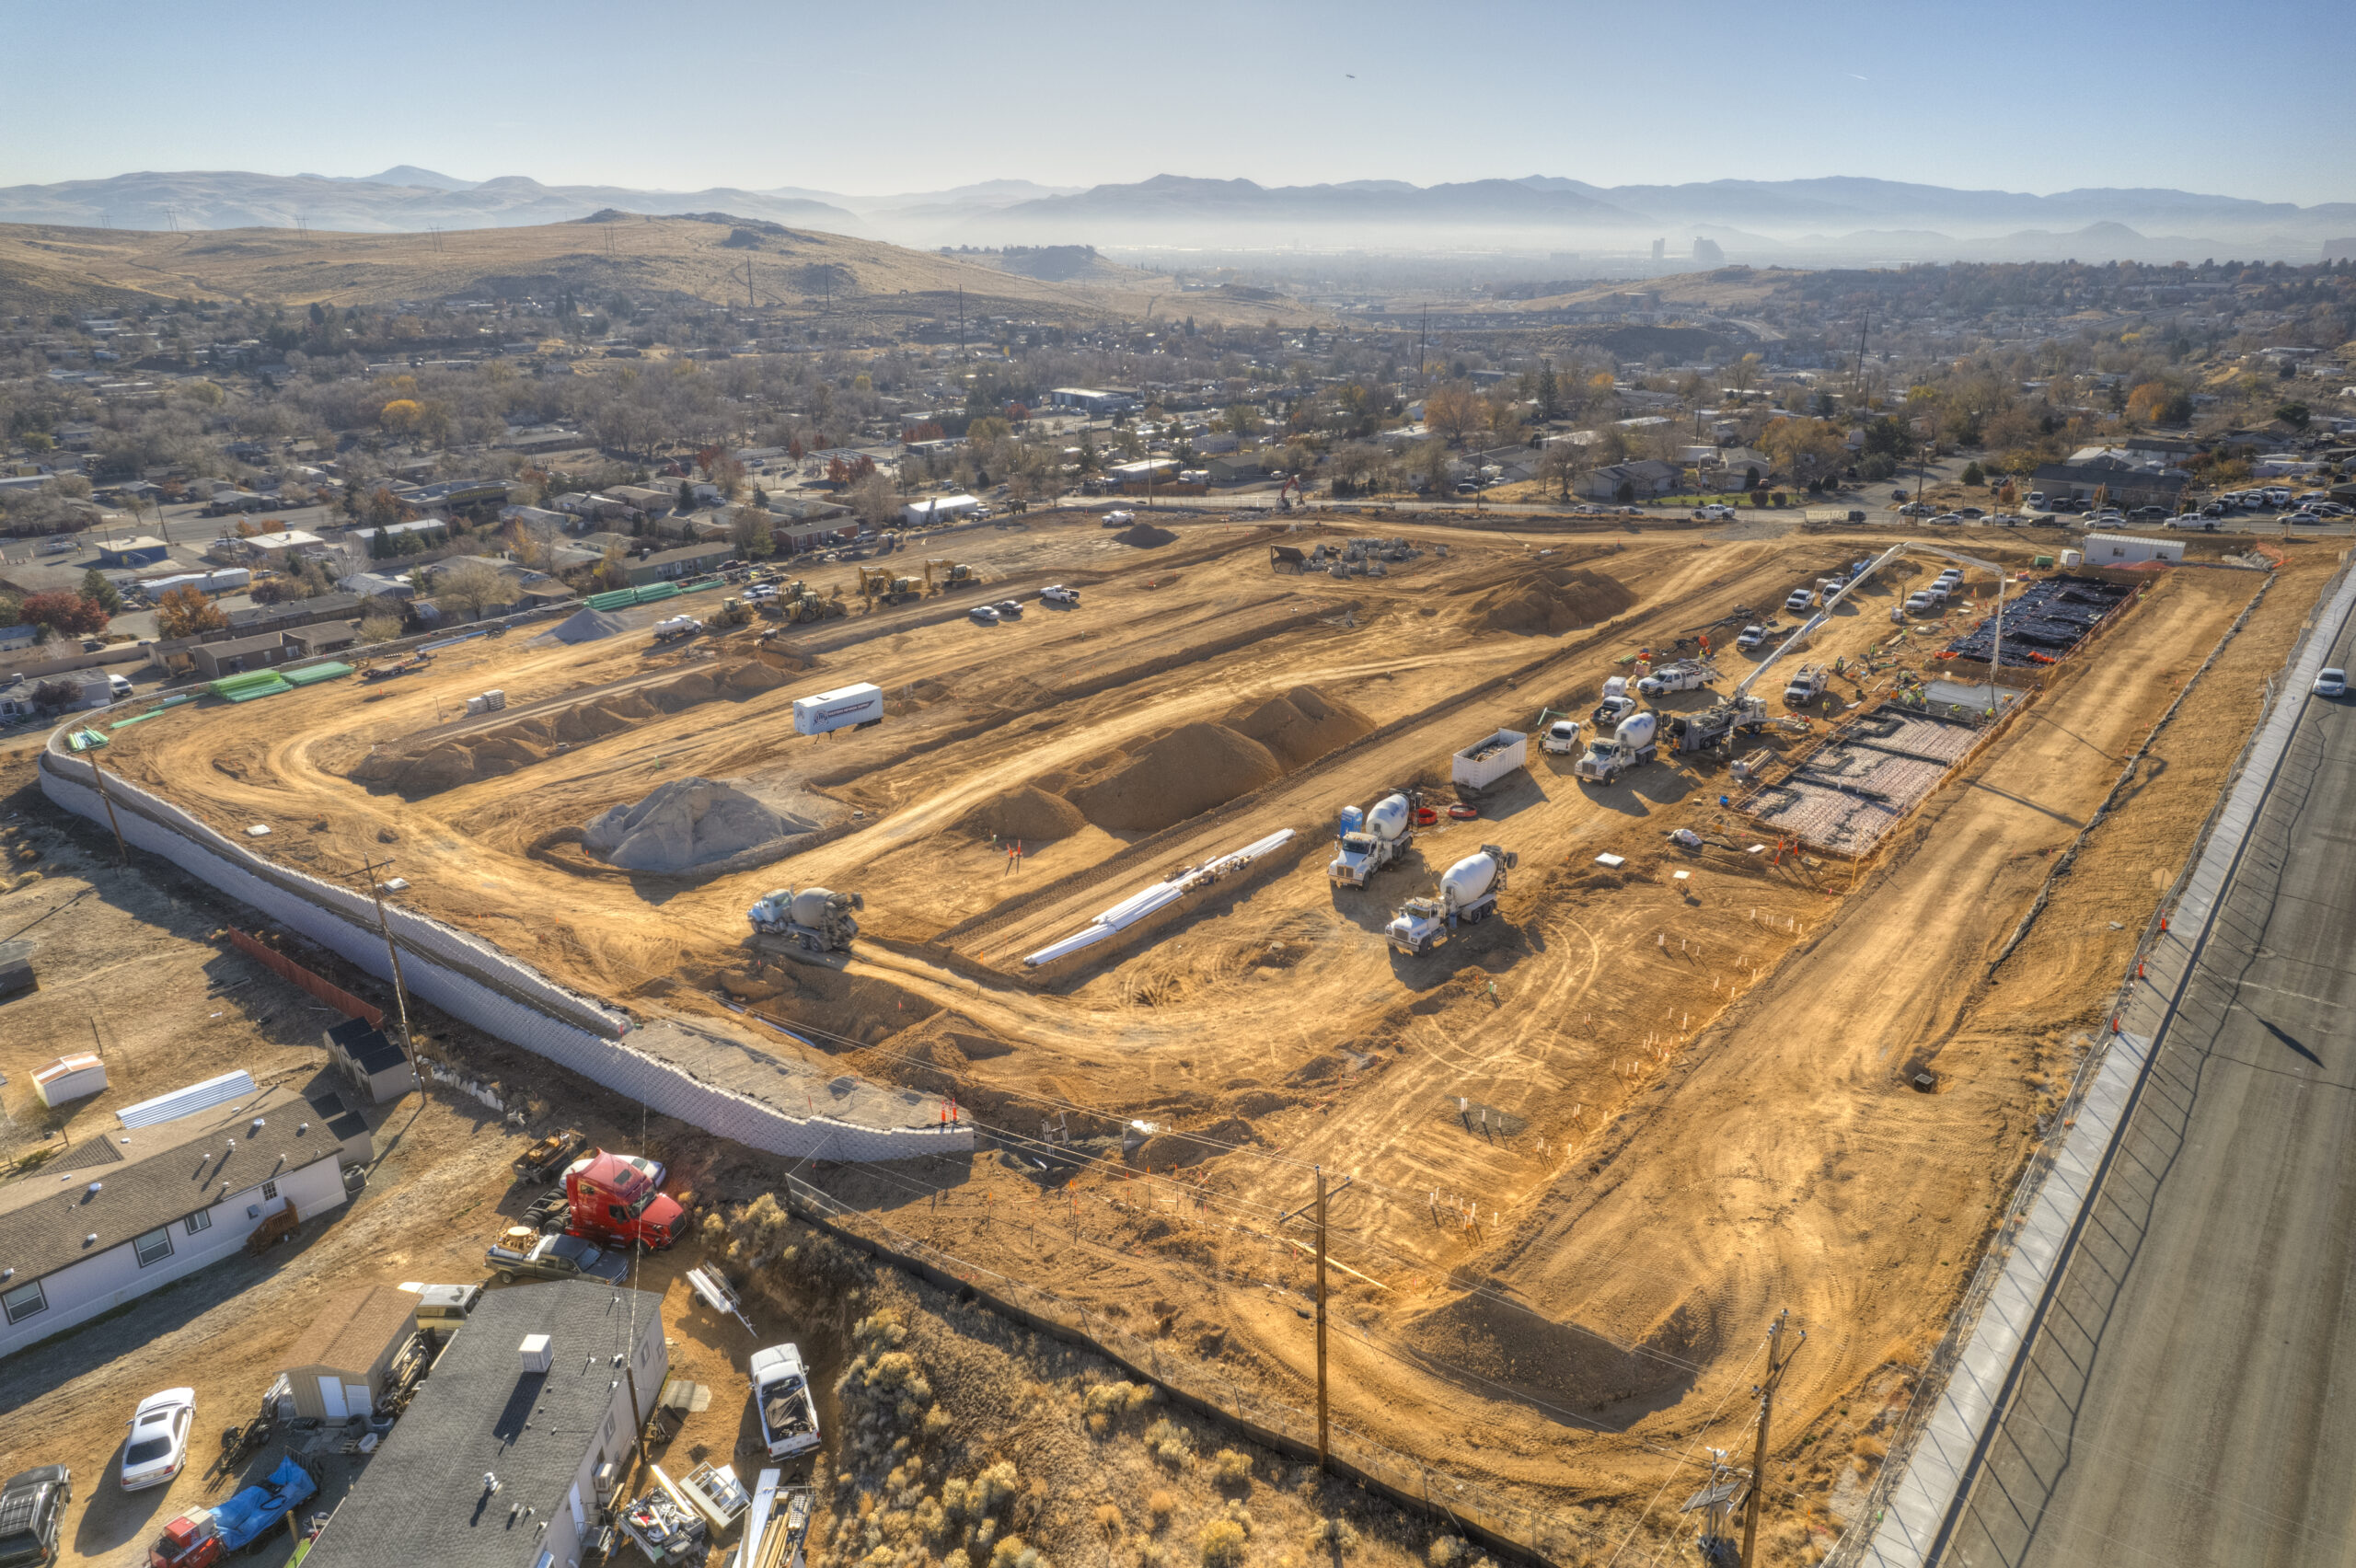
<box><xmin>1941</xmin><ymin>602</ymin><xmax>2356</xmax><ymax>1568</ymax></box>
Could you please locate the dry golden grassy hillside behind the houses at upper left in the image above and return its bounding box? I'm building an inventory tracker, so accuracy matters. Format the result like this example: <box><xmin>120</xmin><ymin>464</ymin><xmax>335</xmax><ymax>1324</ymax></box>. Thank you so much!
<box><xmin>0</xmin><ymin>214</ymin><xmax>1317</xmax><ymax>323</ymax></box>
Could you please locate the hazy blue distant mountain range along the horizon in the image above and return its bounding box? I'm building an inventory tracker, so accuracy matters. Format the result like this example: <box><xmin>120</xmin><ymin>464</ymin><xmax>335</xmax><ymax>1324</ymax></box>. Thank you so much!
<box><xmin>0</xmin><ymin>165</ymin><xmax>2356</xmax><ymax>266</ymax></box>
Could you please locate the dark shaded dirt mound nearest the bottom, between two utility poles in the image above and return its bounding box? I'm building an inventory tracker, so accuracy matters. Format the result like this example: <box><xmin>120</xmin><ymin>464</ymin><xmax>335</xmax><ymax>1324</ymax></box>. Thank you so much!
<box><xmin>1406</xmin><ymin>1295</ymin><xmax>1708</xmax><ymax>1415</ymax></box>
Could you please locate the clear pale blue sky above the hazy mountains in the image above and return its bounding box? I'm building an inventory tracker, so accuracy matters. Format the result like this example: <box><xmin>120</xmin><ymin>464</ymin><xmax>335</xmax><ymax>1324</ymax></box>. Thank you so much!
<box><xmin>0</xmin><ymin>0</ymin><xmax>2356</xmax><ymax>202</ymax></box>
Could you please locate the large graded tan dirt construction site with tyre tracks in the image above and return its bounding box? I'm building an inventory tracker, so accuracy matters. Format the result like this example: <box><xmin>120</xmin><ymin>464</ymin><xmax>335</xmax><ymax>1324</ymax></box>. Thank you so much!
<box><xmin>59</xmin><ymin>513</ymin><xmax>2338</xmax><ymax>1561</ymax></box>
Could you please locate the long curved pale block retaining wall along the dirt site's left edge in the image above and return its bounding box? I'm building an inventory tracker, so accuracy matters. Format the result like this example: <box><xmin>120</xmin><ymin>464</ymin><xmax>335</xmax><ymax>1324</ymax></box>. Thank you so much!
<box><xmin>40</xmin><ymin>725</ymin><xmax>973</xmax><ymax>1160</ymax></box>
